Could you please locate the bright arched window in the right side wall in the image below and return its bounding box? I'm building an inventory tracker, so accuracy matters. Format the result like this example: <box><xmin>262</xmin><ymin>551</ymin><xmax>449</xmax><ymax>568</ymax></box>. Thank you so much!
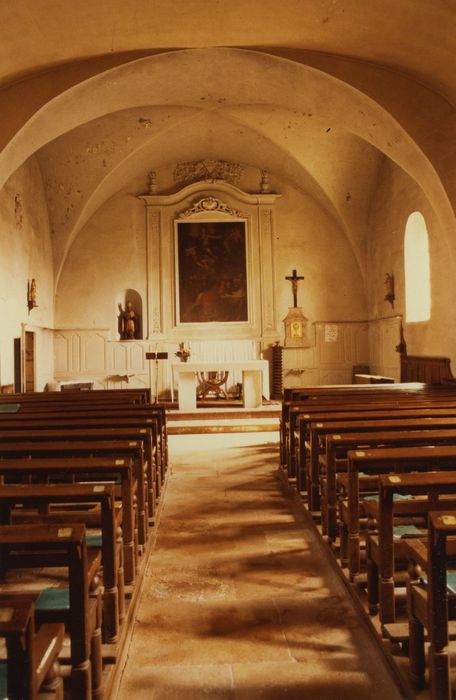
<box><xmin>404</xmin><ymin>211</ymin><xmax>431</xmax><ymax>322</ymax></box>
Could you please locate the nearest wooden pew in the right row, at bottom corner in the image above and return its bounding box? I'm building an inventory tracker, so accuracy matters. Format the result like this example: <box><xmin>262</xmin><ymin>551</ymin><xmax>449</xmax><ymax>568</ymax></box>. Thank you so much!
<box><xmin>405</xmin><ymin>510</ymin><xmax>456</xmax><ymax>700</ymax></box>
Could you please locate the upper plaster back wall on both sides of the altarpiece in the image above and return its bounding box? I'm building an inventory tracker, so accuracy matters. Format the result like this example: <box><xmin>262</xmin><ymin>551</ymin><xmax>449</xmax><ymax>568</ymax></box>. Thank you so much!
<box><xmin>56</xmin><ymin>172</ymin><xmax>367</xmax><ymax>339</ymax></box>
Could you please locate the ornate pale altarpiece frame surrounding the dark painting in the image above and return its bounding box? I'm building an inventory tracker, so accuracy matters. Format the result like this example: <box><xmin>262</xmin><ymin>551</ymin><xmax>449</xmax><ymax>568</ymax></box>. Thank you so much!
<box><xmin>139</xmin><ymin>180</ymin><xmax>280</xmax><ymax>342</ymax></box>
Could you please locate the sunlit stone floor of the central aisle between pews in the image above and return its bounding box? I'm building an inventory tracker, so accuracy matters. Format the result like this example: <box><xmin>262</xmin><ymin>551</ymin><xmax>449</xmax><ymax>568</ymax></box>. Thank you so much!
<box><xmin>117</xmin><ymin>433</ymin><xmax>401</xmax><ymax>700</ymax></box>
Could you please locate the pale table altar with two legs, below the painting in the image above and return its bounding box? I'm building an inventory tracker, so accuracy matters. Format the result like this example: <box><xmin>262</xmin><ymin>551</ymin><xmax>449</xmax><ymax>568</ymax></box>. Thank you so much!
<box><xmin>171</xmin><ymin>360</ymin><xmax>269</xmax><ymax>411</ymax></box>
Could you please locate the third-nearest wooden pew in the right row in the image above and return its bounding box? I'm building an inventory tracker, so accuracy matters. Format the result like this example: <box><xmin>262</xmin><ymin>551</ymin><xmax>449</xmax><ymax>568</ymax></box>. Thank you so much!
<box><xmin>341</xmin><ymin>445</ymin><xmax>456</xmax><ymax>579</ymax></box>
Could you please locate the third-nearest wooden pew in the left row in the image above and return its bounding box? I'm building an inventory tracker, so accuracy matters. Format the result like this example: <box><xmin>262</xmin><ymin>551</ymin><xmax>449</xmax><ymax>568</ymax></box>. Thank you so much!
<box><xmin>0</xmin><ymin>484</ymin><xmax>124</xmax><ymax>644</ymax></box>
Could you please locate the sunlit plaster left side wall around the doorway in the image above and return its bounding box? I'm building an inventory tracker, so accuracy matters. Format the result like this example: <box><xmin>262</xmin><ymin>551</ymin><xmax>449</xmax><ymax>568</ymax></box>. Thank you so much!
<box><xmin>0</xmin><ymin>157</ymin><xmax>54</xmax><ymax>389</ymax></box>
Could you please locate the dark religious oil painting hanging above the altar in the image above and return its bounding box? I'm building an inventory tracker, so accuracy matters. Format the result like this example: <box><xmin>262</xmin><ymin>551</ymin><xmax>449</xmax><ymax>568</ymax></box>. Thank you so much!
<box><xmin>177</xmin><ymin>220</ymin><xmax>248</xmax><ymax>323</ymax></box>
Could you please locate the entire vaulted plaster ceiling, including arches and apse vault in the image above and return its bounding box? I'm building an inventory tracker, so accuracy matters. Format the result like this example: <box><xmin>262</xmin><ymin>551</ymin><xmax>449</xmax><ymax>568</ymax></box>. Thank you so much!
<box><xmin>0</xmin><ymin>0</ymin><xmax>456</xmax><ymax>282</ymax></box>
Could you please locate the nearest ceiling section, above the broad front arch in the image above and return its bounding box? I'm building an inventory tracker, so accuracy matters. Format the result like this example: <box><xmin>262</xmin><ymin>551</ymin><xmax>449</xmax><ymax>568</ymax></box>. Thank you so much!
<box><xmin>0</xmin><ymin>0</ymin><xmax>456</xmax><ymax>101</ymax></box>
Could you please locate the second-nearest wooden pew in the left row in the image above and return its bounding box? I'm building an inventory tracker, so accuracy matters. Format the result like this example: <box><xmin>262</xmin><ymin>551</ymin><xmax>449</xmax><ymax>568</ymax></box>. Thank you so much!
<box><xmin>0</xmin><ymin>525</ymin><xmax>103</xmax><ymax>700</ymax></box>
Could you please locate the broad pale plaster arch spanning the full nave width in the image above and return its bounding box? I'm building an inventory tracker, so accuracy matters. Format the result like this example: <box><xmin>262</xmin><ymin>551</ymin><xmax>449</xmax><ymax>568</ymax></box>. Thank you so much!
<box><xmin>4</xmin><ymin>49</ymin><xmax>453</xmax><ymax>268</ymax></box>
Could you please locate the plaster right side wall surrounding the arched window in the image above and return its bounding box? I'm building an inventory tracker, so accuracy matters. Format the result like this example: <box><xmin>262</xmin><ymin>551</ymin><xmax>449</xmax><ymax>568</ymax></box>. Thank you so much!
<box><xmin>367</xmin><ymin>160</ymin><xmax>456</xmax><ymax>372</ymax></box>
